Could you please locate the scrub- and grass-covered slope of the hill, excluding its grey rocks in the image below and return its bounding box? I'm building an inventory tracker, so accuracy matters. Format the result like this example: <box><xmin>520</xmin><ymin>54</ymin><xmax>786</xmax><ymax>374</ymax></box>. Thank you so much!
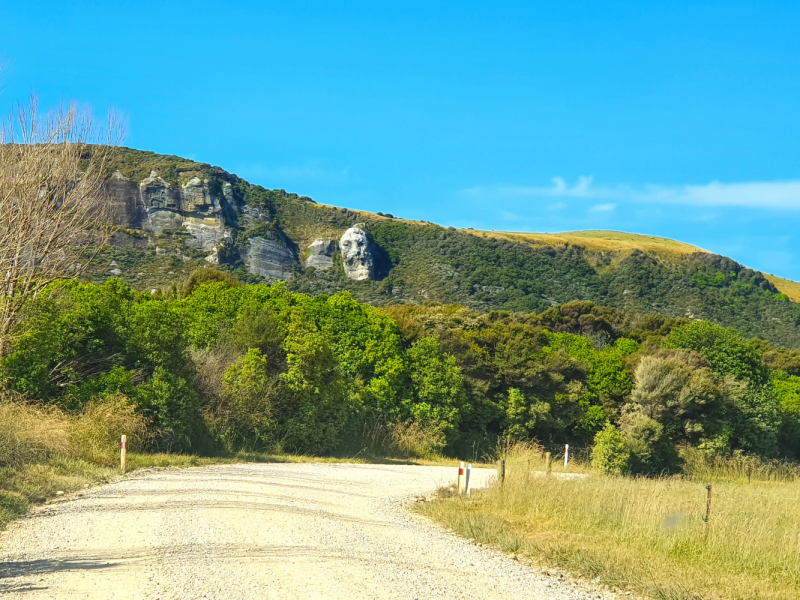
<box><xmin>91</xmin><ymin>149</ymin><xmax>800</xmax><ymax>347</ymax></box>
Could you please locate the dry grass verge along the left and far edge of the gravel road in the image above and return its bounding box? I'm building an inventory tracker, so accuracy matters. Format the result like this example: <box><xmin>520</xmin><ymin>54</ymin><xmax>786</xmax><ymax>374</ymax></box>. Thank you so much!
<box><xmin>0</xmin><ymin>394</ymin><xmax>468</xmax><ymax>529</ymax></box>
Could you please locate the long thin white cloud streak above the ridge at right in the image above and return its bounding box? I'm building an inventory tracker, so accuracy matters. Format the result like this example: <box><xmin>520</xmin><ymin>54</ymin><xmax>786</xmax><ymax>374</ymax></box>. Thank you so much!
<box><xmin>464</xmin><ymin>176</ymin><xmax>800</xmax><ymax>210</ymax></box>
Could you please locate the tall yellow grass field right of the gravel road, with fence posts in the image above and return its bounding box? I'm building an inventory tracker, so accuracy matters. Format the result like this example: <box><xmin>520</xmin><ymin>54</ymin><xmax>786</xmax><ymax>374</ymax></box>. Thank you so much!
<box><xmin>416</xmin><ymin>440</ymin><xmax>800</xmax><ymax>600</ymax></box>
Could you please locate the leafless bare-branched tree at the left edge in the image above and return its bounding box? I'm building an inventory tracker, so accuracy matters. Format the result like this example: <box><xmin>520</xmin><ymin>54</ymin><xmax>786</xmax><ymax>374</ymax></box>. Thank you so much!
<box><xmin>0</xmin><ymin>100</ymin><xmax>121</xmax><ymax>356</ymax></box>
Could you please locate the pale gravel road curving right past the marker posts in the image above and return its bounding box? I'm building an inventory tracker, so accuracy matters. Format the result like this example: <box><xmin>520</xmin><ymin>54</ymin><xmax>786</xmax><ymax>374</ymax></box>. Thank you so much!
<box><xmin>0</xmin><ymin>463</ymin><xmax>615</xmax><ymax>600</ymax></box>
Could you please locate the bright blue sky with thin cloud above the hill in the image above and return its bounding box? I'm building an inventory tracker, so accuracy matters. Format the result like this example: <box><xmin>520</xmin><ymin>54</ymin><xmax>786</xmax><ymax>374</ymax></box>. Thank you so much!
<box><xmin>0</xmin><ymin>0</ymin><xmax>800</xmax><ymax>280</ymax></box>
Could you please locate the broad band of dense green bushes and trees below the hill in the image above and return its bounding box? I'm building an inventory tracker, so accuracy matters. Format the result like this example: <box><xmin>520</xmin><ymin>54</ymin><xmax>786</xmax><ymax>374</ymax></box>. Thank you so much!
<box><xmin>0</xmin><ymin>271</ymin><xmax>800</xmax><ymax>473</ymax></box>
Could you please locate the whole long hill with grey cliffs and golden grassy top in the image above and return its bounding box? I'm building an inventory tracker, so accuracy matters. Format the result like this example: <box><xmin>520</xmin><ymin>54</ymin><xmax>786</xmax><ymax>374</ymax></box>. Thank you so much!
<box><xmin>89</xmin><ymin>149</ymin><xmax>800</xmax><ymax>347</ymax></box>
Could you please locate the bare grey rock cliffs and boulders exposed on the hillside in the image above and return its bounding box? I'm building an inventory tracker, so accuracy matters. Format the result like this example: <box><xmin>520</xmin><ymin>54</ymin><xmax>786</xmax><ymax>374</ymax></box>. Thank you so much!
<box><xmin>106</xmin><ymin>166</ymin><xmax>378</xmax><ymax>281</ymax></box>
